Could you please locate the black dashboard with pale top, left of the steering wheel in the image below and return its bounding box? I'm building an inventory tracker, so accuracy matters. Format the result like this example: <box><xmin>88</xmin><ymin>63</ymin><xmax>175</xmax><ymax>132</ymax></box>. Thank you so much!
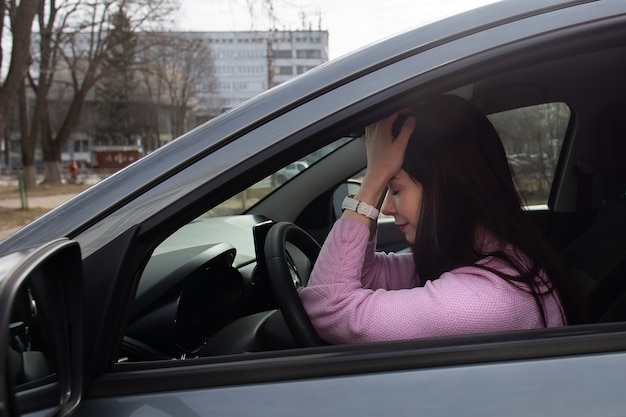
<box><xmin>119</xmin><ymin>215</ymin><xmax>300</xmax><ymax>361</ymax></box>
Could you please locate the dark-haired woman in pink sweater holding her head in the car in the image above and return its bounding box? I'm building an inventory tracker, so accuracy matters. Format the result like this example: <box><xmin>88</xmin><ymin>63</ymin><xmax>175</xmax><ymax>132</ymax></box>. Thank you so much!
<box><xmin>300</xmin><ymin>95</ymin><xmax>582</xmax><ymax>343</ymax></box>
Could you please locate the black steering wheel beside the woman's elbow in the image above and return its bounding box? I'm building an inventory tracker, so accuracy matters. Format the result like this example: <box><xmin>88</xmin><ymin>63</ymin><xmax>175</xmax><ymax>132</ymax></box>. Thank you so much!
<box><xmin>265</xmin><ymin>222</ymin><xmax>325</xmax><ymax>347</ymax></box>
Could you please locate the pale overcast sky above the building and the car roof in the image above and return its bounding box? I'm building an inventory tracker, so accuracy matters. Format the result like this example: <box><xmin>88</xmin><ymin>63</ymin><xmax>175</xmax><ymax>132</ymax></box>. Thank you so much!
<box><xmin>176</xmin><ymin>0</ymin><xmax>498</xmax><ymax>59</ymax></box>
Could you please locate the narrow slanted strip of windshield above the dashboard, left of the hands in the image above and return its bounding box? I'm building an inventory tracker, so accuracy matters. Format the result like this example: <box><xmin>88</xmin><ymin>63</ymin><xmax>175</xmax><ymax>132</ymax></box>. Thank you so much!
<box><xmin>201</xmin><ymin>137</ymin><xmax>353</xmax><ymax>218</ymax></box>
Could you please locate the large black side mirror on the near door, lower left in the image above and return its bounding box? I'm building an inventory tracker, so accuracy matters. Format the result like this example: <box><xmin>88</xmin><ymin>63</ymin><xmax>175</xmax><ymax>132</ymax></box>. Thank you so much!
<box><xmin>0</xmin><ymin>239</ymin><xmax>83</xmax><ymax>417</ymax></box>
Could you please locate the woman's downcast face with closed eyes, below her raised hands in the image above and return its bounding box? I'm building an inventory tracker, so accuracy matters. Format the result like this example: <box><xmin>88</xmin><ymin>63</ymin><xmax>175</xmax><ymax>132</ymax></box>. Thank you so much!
<box><xmin>382</xmin><ymin>170</ymin><xmax>422</xmax><ymax>244</ymax></box>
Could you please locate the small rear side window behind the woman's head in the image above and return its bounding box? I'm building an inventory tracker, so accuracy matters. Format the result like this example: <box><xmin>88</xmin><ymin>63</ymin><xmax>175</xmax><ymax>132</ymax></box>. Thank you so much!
<box><xmin>489</xmin><ymin>103</ymin><xmax>570</xmax><ymax>206</ymax></box>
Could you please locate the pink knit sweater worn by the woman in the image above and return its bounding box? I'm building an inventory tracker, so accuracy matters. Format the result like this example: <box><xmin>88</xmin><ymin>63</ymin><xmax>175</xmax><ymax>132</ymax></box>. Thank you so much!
<box><xmin>300</xmin><ymin>218</ymin><xmax>564</xmax><ymax>343</ymax></box>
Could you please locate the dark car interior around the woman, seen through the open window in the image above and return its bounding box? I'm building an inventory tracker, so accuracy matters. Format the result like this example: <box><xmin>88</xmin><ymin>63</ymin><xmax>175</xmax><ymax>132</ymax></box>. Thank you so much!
<box><xmin>109</xmin><ymin>34</ymin><xmax>626</xmax><ymax>362</ymax></box>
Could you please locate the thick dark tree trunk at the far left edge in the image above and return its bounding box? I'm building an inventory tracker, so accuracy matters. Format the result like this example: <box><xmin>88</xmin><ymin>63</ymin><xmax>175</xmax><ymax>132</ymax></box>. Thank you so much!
<box><xmin>0</xmin><ymin>0</ymin><xmax>43</xmax><ymax>173</ymax></box>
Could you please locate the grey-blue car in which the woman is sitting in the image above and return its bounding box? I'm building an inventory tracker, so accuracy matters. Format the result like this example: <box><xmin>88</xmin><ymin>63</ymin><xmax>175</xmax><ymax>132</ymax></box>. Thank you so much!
<box><xmin>0</xmin><ymin>0</ymin><xmax>626</xmax><ymax>416</ymax></box>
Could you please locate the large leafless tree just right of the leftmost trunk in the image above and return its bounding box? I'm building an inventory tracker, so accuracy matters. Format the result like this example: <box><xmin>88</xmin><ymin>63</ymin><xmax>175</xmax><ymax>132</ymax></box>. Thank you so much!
<box><xmin>22</xmin><ymin>0</ymin><xmax>178</xmax><ymax>186</ymax></box>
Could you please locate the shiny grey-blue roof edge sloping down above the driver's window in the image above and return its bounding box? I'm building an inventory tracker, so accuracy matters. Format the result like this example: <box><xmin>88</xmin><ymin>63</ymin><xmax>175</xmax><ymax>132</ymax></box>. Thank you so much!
<box><xmin>0</xmin><ymin>0</ymin><xmax>626</xmax><ymax>254</ymax></box>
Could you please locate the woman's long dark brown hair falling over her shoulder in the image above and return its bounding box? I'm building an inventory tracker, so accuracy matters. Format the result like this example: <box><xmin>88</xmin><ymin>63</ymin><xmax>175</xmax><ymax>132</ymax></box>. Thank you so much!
<box><xmin>403</xmin><ymin>95</ymin><xmax>584</xmax><ymax>326</ymax></box>
